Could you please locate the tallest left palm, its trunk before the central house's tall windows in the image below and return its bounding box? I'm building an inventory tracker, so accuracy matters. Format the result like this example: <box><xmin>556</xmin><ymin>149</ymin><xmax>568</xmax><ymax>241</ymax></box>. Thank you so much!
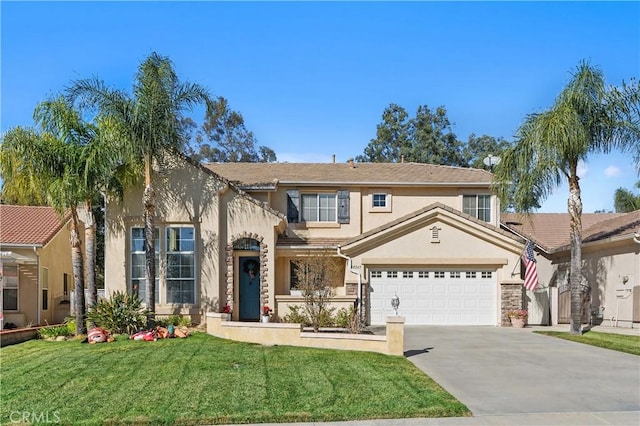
<box><xmin>68</xmin><ymin>52</ymin><xmax>210</xmax><ymax>319</ymax></box>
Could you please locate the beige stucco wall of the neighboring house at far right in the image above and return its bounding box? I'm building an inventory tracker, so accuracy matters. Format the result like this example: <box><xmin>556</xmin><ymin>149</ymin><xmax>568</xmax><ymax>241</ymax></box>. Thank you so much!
<box><xmin>537</xmin><ymin>237</ymin><xmax>640</xmax><ymax>327</ymax></box>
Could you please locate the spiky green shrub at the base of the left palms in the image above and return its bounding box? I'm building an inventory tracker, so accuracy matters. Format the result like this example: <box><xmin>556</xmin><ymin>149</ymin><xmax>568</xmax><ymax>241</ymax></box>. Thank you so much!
<box><xmin>87</xmin><ymin>291</ymin><xmax>149</xmax><ymax>334</ymax></box>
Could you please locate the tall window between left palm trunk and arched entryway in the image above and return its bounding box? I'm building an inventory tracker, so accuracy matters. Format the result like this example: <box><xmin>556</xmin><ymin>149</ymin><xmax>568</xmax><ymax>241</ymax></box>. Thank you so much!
<box><xmin>165</xmin><ymin>226</ymin><xmax>196</xmax><ymax>304</ymax></box>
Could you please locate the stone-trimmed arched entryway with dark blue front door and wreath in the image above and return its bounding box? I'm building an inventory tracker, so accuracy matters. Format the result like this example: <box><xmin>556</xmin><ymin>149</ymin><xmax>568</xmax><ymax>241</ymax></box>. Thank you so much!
<box><xmin>227</xmin><ymin>233</ymin><xmax>269</xmax><ymax>321</ymax></box>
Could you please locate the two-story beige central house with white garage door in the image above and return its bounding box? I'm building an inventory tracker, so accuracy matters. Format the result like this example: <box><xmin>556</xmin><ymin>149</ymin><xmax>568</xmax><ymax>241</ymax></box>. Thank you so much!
<box><xmin>105</xmin><ymin>155</ymin><xmax>523</xmax><ymax>325</ymax></box>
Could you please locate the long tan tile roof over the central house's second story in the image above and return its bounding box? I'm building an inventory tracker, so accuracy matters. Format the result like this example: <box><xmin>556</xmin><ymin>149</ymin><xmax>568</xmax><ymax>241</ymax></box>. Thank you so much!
<box><xmin>204</xmin><ymin>163</ymin><xmax>492</xmax><ymax>186</ymax></box>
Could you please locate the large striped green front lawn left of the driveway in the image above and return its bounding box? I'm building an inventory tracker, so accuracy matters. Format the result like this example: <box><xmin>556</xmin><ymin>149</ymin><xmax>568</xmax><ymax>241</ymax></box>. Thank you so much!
<box><xmin>0</xmin><ymin>333</ymin><xmax>471</xmax><ymax>425</ymax></box>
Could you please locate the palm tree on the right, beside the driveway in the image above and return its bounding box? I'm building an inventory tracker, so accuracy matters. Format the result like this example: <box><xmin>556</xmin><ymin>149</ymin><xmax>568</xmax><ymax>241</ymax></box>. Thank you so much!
<box><xmin>494</xmin><ymin>61</ymin><xmax>640</xmax><ymax>334</ymax></box>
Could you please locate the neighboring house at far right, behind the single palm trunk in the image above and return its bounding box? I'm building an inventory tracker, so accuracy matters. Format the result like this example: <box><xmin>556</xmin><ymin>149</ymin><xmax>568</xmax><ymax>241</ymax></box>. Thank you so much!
<box><xmin>502</xmin><ymin>210</ymin><xmax>640</xmax><ymax>327</ymax></box>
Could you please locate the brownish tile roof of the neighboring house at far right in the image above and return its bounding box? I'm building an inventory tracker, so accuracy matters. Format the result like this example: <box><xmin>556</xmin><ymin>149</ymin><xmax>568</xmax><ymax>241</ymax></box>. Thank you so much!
<box><xmin>500</xmin><ymin>210</ymin><xmax>640</xmax><ymax>252</ymax></box>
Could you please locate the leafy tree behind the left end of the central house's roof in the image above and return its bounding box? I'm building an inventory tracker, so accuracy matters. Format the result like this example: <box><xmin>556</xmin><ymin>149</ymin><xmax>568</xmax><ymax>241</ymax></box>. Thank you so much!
<box><xmin>190</xmin><ymin>97</ymin><xmax>276</xmax><ymax>163</ymax></box>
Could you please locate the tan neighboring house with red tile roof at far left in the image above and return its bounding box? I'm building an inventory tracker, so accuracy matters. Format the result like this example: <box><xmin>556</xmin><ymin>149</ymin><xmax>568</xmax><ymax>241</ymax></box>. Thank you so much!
<box><xmin>0</xmin><ymin>205</ymin><xmax>73</xmax><ymax>327</ymax></box>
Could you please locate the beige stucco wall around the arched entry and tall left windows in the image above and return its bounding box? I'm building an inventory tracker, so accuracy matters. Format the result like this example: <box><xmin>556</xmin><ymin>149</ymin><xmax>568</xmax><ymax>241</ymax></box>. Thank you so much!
<box><xmin>105</xmin><ymin>158</ymin><xmax>281</xmax><ymax>322</ymax></box>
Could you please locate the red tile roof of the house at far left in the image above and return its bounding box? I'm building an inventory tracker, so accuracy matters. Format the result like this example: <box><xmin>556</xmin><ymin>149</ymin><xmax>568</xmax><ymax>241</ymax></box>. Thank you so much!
<box><xmin>0</xmin><ymin>204</ymin><xmax>67</xmax><ymax>245</ymax></box>
